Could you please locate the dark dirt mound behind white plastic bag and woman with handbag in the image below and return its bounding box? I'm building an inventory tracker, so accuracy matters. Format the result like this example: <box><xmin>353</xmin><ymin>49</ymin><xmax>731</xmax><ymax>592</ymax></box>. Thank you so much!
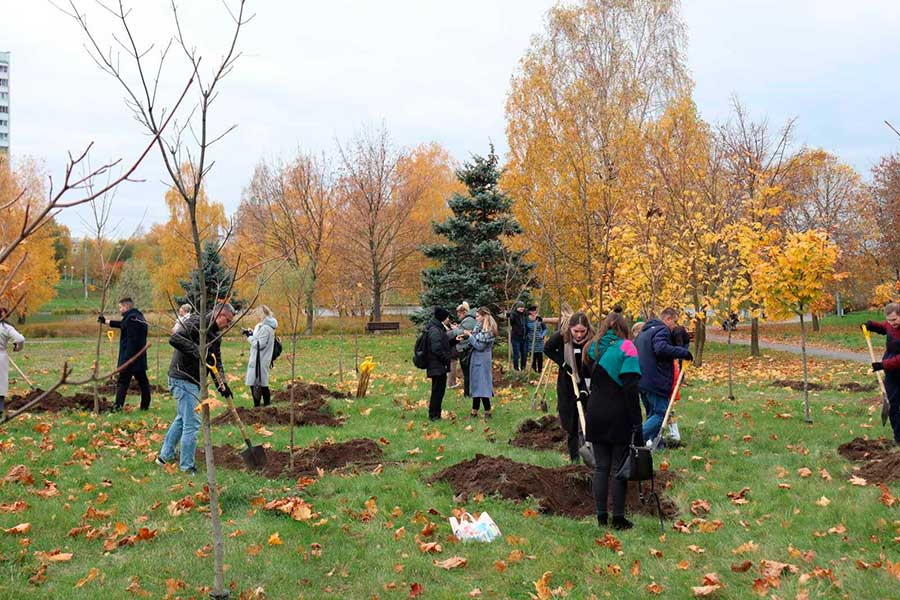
<box><xmin>429</xmin><ymin>454</ymin><xmax>678</xmax><ymax>518</ymax></box>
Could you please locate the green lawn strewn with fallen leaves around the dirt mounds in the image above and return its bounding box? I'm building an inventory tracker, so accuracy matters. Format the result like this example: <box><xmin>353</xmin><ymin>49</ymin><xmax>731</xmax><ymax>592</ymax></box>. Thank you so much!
<box><xmin>0</xmin><ymin>326</ymin><xmax>900</xmax><ymax>600</ymax></box>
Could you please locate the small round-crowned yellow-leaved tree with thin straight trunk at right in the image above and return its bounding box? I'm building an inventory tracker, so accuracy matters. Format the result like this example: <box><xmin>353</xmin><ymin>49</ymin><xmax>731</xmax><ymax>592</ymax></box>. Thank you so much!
<box><xmin>753</xmin><ymin>229</ymin><xmax>839</xmax><ymax>423</ymax></box>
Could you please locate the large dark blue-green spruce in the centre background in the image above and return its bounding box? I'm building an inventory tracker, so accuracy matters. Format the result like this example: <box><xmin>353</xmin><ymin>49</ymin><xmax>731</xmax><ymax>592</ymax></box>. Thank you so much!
<box><xmin>420</xmin><ymin>148</ymin><xmax>534</xmax><ymax>320</ymax></box>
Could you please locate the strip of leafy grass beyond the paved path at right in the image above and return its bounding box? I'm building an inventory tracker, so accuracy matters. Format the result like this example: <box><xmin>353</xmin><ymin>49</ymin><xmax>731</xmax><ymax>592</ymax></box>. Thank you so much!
<box><xmin>711</xmin><ymin>311</ymin><xmax>884</xmax><ymax>356</ymax></box>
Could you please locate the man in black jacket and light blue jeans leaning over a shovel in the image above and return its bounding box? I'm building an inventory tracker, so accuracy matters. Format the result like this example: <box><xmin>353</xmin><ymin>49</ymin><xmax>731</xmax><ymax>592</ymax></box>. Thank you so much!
<box><xmin>156</xmin><ymin>303</ymin><xmax>234</xmax><ymax>474</ymax></box>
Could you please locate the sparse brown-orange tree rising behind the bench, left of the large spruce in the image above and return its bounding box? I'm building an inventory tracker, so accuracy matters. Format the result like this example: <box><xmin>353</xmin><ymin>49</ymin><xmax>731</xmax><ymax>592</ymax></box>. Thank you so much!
<box><xmin>335</xmin><ymin>129</ymin><xmax>429</xmax><ymax>321</ymax></box>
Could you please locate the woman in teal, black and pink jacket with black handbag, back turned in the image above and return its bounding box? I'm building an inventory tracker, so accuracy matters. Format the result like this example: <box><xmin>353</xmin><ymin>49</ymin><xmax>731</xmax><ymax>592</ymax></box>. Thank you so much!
<box><xmin>582</xmin><ymin>312</ymin><xmax>643</xmax><ymax>529</ymax></box>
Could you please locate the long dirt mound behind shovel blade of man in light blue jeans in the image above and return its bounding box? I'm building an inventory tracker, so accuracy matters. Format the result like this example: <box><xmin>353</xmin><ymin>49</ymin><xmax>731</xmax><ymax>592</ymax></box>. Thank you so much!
<box><xmin>197</xmin><ymin>439</ymin><xmax>382</xmax><ymax>479</ymax></box>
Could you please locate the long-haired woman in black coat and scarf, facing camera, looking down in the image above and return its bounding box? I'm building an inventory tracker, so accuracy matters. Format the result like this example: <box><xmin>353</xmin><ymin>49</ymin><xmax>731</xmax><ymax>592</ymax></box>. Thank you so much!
<box><xmin>544</xmin><ymin>312</ymin><xmax>594</xmax><ymax>464</ymax></box>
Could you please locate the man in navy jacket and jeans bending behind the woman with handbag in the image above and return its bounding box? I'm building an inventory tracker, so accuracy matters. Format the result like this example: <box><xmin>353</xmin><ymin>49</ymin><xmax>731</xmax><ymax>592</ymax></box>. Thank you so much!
<box><xmin>634</xmin><ymin>308</ymin><xmax>694</xmax><ymax>442</ymax></box>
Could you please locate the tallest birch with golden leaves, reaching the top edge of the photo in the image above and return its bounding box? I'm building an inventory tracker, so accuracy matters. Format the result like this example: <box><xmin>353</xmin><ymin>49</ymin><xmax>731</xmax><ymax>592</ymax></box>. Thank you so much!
<box><xmin>506</xmin><ymin>0</ymin><xmax>689</xmax><ymax>316</ymax></box>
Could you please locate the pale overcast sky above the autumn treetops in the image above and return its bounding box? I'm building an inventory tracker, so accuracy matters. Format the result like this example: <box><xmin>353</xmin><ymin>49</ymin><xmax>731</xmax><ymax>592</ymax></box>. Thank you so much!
<box><xmin>0</xmin><ymin>0</ymin><xmax>900</xmax><ymax>236</ymax></box>
